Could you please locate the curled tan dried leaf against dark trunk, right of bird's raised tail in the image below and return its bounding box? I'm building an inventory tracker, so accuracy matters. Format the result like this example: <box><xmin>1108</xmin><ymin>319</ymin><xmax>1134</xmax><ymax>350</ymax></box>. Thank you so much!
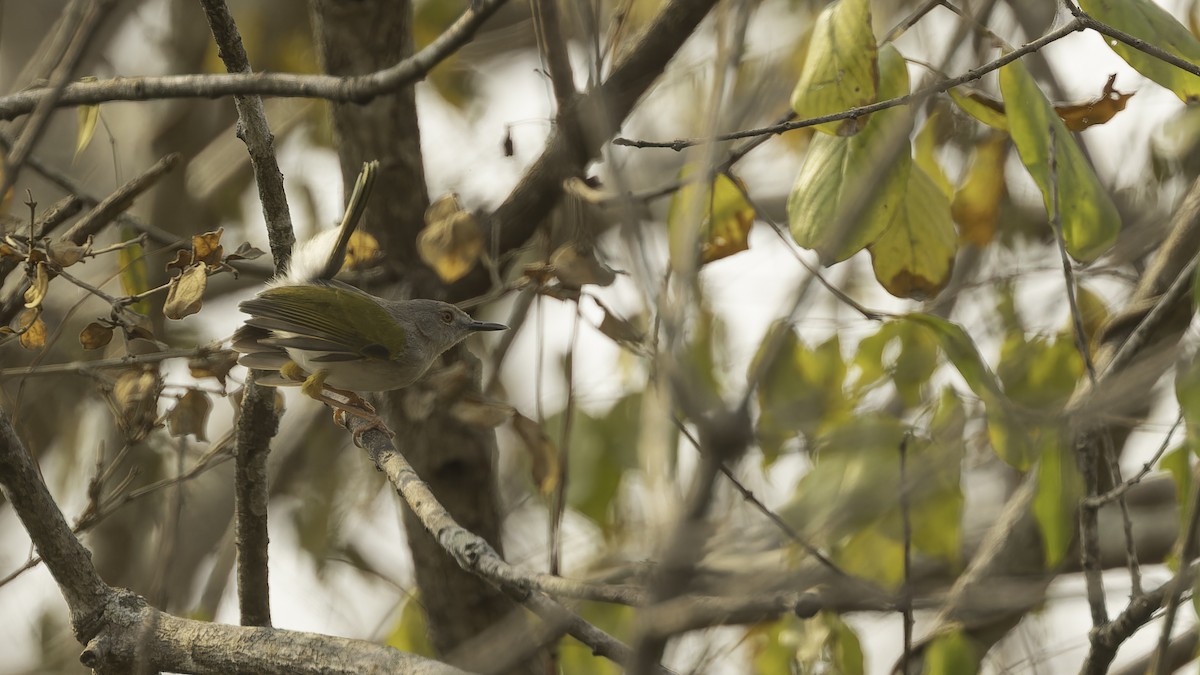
<box><xmin>416</xmin><ymin>195</ymin><xmax>484</xmax><ymax>283</ymax></box>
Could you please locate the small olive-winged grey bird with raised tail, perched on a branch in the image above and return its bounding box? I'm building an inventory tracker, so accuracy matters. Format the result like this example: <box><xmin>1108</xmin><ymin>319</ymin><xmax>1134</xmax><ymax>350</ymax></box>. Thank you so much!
<box><xmin>233</xmin><ymin>159</ymin><xmax>508</xmax><ymax>424</ymax></box>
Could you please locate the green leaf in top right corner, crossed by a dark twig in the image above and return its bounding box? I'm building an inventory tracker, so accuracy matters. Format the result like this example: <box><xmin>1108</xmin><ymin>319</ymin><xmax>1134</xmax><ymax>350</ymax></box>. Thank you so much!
<box><xmin>1079</xmin><ymin>0</ymin><xmax>1200</xmax><ymax>103</ymax></box>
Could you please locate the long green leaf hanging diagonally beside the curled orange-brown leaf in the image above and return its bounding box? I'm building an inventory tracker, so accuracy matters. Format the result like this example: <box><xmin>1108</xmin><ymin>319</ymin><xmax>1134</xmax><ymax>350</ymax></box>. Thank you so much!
<box><xmin>1000</xmin><ymin>61</ymin><xmax>1121</xmax><ymax>262</ymax></box>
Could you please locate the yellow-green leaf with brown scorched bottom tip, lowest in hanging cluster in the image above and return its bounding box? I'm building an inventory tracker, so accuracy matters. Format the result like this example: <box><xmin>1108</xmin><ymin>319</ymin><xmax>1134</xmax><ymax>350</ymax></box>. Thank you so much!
<box><xmin>868</xmin><ymin>167</ymin><xmax>959</xmax><ymax>300</ymax></box>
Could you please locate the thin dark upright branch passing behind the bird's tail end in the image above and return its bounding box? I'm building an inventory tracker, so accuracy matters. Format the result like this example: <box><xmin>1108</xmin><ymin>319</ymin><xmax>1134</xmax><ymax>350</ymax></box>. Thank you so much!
<box><xmin>200</xmin><ymin>0</ymin><xmax>295</xmax><ymax>626</ymax></box>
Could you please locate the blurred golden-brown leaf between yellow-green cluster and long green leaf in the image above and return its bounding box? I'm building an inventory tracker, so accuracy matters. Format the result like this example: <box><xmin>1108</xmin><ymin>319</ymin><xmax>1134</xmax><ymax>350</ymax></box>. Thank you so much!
<box><xmin>950</xmin><ymin>133</ymin><xmax>1008</xmax><ymax>246</ymax></box>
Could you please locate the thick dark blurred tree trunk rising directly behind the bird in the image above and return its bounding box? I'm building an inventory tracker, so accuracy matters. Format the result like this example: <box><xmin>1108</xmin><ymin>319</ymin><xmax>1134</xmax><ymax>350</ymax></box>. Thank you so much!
<box><xmin>312</xmin><ymin>0</ymin><xmax>520</xmax><ymax>655</ymax></box>
